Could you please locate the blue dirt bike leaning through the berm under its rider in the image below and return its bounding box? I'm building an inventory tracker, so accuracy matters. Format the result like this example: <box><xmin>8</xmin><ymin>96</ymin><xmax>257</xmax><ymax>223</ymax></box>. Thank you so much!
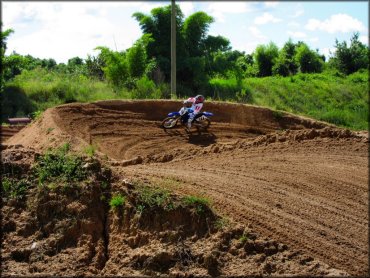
<box><xmin>162</xmin><ymin>107</ymin><xmax>213</xmax><ymax>130</ymax></box>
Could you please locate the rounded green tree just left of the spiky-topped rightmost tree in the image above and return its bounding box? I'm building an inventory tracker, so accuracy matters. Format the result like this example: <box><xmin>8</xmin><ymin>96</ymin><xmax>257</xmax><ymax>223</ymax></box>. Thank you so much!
<box><xmin>295</xmin><ymin>43</ymin><xmax>324</xmax><ymax>73</ymax></box>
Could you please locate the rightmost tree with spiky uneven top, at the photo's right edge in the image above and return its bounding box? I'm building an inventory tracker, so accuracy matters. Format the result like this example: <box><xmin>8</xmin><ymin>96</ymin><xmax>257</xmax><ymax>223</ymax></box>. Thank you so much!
<box><xmin>331</xmin><ymin>33</ymin><xmax>369</xmax><ymax>74</ymax></box>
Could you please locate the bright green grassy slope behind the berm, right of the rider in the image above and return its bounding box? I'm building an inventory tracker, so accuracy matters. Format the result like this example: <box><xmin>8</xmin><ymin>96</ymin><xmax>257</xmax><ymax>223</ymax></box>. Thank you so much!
<box><xmin>211</xmin><ymin>71</ymin><xmax>369</xmax><ymax>130</ymax></box>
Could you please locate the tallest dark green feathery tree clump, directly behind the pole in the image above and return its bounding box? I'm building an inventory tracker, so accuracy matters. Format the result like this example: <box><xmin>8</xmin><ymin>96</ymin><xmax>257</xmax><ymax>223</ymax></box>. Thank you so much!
<box><xmin>133</xmin><ymin>5</ymin><xmax>225</xmax><ymax>93</ymax></box>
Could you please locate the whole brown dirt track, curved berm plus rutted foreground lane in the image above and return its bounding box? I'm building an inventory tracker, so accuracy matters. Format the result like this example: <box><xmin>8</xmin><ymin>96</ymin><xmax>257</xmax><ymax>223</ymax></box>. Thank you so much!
<box><xmin>6</xmin><ymin>101</ymin><xmax>369</xmax><ymax>276</ymax></box>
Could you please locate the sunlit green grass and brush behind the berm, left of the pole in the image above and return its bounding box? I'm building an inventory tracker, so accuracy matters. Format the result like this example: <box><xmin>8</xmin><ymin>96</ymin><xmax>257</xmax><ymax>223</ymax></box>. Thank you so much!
<box><xmin>1</xmin><ymin>68</ymin><xmax>129</xmax><ymax>122</ymax></box>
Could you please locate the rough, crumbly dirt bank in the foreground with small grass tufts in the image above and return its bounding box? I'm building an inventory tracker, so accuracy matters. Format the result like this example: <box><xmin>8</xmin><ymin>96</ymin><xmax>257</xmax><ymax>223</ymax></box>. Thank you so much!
<box><xmin>2</xmin><ymin>148</ymin><xmax>346</xmax><ymax>276</ymax></box>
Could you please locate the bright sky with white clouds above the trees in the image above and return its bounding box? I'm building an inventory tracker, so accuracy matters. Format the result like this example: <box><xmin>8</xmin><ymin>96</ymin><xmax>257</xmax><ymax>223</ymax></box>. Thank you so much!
<box><xmin>1</xmin><ymin>1</ymin><xmax>369</xmax><ymax>63</ymax></box>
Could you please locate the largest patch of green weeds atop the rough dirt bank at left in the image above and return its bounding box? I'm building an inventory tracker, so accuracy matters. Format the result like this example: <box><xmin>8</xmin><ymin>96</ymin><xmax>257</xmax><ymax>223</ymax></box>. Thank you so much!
<box><xmin>35</xmin><ymin>143</ymin><xmax>87</xmax><ymax>185</ymax></box>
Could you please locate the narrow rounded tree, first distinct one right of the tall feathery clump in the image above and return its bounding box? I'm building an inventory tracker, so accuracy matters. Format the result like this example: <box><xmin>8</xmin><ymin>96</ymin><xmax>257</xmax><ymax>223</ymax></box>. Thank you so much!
<box><xmin>254</xmin><ymin>42</ymin><xmax>279</xmax><ymax>77</ymax></box>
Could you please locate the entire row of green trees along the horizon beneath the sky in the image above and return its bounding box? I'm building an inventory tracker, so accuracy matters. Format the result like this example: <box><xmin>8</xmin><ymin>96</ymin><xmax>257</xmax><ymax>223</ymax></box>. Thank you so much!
<box><xmin>1</xmin><ymin>2</ymin><xmax>369</xmax><ymax>97</ymax></box>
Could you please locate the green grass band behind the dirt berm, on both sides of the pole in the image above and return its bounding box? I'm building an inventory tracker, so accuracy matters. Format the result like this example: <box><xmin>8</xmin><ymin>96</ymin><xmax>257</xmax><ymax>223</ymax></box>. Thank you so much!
<box><xmin>1</xmin><ymin>68</ymin><xmax>369</xmax><ymax>130</ymax></box>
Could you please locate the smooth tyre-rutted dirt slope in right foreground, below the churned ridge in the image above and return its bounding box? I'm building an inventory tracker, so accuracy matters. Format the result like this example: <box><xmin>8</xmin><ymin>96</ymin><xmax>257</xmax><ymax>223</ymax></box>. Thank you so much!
<box><xmin>123</xmin><ymin>142</ymin><xmax>368</xmax><ymax>275</ymax></box>
